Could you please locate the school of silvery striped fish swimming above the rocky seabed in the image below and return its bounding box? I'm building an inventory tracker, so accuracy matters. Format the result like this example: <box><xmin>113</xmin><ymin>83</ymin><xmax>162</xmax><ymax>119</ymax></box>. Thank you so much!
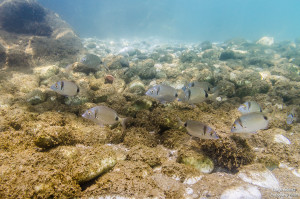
<box><xmin>50</xmin><ymin>80</ymin><xmax>297</xmax><ymax>139</ymax></box>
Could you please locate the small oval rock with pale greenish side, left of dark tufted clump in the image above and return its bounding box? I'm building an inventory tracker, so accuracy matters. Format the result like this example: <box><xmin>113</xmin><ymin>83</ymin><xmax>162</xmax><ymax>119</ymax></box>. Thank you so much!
<box><xmin>178</xmin><ymin>150</ymin><xmax>214</xmax><ymax>173</ymax></box>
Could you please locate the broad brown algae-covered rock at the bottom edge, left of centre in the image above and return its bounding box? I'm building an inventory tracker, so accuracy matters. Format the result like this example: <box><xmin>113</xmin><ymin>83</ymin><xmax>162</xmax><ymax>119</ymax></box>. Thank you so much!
<box><xmin>83</xmin><ymin>161</ymin><xmax>164</xmax><ymax>198</ymax></box>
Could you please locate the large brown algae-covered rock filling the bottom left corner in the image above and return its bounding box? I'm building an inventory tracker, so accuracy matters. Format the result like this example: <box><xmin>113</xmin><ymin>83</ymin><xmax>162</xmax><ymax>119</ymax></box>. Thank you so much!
<box><xmin>0</xmin><ymin>149</ymin><xmax>81</xmax><ymax>198</ymax></box>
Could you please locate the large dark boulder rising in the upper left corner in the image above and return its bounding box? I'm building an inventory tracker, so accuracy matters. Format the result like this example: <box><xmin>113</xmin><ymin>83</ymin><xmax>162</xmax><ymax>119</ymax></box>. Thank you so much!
<box><xmin>0</xmin><ymin>0</ymin><xmax>83</xmax><ymax>68</ymax></box>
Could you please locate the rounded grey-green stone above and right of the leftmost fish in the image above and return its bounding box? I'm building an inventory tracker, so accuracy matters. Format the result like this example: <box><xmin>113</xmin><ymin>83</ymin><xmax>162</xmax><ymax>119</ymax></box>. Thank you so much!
<box><xmin>73</xmin><ymin>54</ymin><xmax>102</xmax><ymax>75</ymax></box>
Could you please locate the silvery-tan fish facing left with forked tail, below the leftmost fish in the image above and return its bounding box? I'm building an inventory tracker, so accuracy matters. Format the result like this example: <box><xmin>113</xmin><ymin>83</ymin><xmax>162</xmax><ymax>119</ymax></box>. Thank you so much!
<box><xmin>82</xmin><ymin>106</ymin><xmax>128</xmax><ymax>129</ymax></box>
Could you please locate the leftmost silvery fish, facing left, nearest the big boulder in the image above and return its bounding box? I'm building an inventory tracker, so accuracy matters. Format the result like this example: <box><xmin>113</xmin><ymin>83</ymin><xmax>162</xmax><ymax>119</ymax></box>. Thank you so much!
<box><xmin>50</xmin><ymin>80</ymin><xmax>80</xmax><ymax>96</ymax></box>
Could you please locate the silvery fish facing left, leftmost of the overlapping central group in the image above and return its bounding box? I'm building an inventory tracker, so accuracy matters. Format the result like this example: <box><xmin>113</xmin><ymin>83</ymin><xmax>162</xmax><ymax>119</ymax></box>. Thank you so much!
<box><xmin>146</xmin><ymin>84</ymin><xmax>178</xmax><ymax>104</ymax></box>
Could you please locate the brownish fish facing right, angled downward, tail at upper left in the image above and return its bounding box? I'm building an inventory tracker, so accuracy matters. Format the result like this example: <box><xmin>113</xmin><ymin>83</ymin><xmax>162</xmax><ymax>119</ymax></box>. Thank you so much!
<box><xmin>177</xmin><ymin>118</ymin><xmax>219</xmax><ymax>139</ymax></box>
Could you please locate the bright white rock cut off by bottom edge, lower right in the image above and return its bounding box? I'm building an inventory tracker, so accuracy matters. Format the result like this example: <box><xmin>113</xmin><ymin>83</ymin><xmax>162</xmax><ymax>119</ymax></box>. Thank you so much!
<box><xmin>220</xmin><ymin>185</ymin><xmax>261</xmax><ymax>199</ymax></box>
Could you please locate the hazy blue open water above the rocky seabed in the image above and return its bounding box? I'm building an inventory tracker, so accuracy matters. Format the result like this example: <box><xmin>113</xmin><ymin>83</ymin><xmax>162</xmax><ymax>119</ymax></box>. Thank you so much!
<box><xmin>39</xmin><ymin>0</ymin><xmax>300</xmax><ymax>41</ymax></box>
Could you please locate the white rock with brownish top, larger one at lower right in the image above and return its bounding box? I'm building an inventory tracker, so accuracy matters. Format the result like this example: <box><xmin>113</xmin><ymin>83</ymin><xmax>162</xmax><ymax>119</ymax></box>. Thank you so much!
<box><xmin>238</xmin><ymin>164</ymin><xmax>280</xmax><ymax>189</ymax></box>
